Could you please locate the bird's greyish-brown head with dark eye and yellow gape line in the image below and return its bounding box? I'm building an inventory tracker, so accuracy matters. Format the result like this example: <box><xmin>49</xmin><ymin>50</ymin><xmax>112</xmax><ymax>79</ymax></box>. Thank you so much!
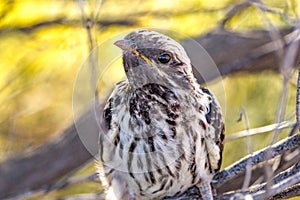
<box><xmin>115</xmin><ymin>30</ymin><xmax>195</xmax><ymax>89</ymax></box>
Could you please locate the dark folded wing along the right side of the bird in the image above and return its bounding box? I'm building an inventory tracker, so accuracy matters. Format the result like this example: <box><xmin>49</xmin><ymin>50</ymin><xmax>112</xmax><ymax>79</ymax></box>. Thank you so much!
<box><xmin>201</xmin><ymin>87</ymin><xmax>225</xmax><ymax>171</ymax></box>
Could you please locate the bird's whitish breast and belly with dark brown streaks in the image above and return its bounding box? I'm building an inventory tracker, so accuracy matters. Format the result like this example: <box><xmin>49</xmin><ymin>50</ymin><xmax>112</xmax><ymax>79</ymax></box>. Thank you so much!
<box><xmin>102</xmin><ymin>84</ymin><xmax>212</xmax><ymax>198</ymax></box>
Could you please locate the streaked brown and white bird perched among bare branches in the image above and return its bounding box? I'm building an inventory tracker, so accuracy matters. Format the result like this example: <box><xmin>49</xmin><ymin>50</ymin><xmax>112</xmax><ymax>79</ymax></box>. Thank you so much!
<box><xmin>98</xmin><ymin>29</ymin><xmax>225</xmax><ymax>200</ymax></box>
